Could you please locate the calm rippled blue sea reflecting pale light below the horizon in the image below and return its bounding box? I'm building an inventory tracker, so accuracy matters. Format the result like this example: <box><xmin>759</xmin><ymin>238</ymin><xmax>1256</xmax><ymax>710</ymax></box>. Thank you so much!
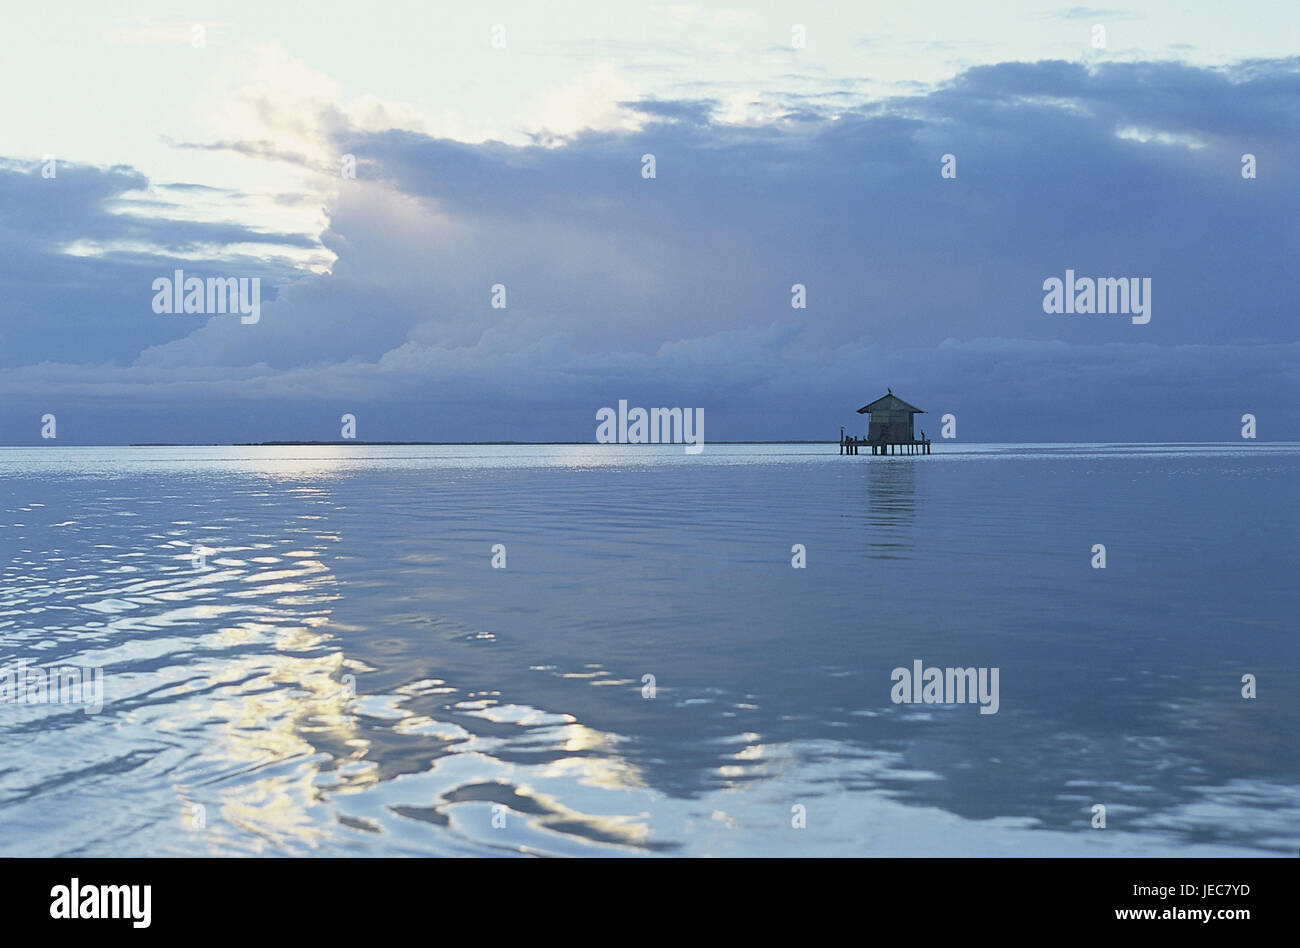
<box><xmin>0</xmin><ymin>443</ymin><xmax>1300</xmax><ymax>857</ymax></box>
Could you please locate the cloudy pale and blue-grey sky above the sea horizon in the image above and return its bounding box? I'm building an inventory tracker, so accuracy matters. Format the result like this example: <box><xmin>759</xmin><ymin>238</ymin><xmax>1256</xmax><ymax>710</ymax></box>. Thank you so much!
<box><xmin>0</xmin><ymin>0</ymin><xmax>1300</xmax><ymax>445</ymax></box>
